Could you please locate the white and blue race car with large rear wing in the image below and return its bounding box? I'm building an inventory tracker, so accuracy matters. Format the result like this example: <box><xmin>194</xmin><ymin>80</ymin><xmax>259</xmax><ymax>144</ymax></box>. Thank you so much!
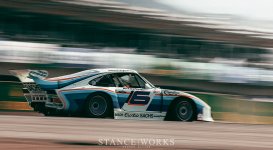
<box><xmin>10</xmin><ymin>68</ymin><xmax>213</xmax><ymax>121</ymax></box>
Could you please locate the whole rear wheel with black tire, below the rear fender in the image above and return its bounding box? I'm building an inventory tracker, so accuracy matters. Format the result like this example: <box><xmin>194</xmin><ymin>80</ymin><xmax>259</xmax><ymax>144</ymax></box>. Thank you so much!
<box><xmin>85</xmin><ymin>93</ymin><xmax>112</xmax><ymax>118</ymax></box>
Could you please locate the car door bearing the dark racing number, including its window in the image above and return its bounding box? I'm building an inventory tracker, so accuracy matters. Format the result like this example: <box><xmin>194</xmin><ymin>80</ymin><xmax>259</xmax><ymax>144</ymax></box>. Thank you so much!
<box><xmin>115</xmin><ymin>73</ymin><xmax>159</xmax><ymax>112</ymax></box>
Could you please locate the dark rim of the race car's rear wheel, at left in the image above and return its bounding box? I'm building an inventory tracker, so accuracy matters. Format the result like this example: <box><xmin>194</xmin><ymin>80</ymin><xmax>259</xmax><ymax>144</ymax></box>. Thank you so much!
<box><xmin>89</xmin><ymin>96</ymin><xmax>107</xmax><ymax>116</ymax></box>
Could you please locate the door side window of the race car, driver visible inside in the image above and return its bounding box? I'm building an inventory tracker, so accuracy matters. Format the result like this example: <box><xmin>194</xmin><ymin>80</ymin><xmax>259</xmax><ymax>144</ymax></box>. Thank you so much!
<box><xmin>117</xmin><ymin>73</ymin><xmax>141</xmax><ymax>88</ymax></box>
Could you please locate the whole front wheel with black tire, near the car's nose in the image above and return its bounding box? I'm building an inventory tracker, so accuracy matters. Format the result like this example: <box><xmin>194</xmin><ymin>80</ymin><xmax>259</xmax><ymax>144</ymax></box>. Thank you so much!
<box><xmin>171</xmin><ymin>100</ymin><xmax>196</xmax><ymax>122</ymax></box>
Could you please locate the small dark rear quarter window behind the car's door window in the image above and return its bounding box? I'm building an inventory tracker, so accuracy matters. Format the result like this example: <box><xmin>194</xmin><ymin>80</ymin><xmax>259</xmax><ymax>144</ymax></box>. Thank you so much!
<box><xmin>89</xmin><ymin>75</ymin><xmax>116</xmax><ymax>87</ymax></box>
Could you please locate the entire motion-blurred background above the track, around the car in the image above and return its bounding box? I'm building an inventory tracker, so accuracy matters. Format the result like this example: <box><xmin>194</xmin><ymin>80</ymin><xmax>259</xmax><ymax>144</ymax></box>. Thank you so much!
<box><xmin>0</xmin><ymin>0</ymin><xmax>273</xmax><ymax>124</ymax></box>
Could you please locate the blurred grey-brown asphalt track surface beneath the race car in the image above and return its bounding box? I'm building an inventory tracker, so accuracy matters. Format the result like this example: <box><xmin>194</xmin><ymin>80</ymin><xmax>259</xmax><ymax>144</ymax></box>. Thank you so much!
<box><xmin>0</xmin><ymin>112</ymin><xmax>273</xmax><ymax>150</ymax></box>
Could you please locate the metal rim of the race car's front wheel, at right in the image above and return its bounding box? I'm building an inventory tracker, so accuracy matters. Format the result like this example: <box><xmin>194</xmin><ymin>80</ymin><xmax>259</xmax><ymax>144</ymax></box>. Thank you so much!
<box><xmin>176</xmin><ymin>101</ymin><xmax>193</xmax><ymax>121</ymax></box>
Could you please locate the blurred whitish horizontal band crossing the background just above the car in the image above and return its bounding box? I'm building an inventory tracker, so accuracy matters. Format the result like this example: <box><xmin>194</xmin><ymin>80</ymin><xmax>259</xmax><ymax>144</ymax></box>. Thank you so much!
<box><xmin>0</xmin><ymin>41</ymin><xmax>273</xmax><ymax>85</ymax></box>
